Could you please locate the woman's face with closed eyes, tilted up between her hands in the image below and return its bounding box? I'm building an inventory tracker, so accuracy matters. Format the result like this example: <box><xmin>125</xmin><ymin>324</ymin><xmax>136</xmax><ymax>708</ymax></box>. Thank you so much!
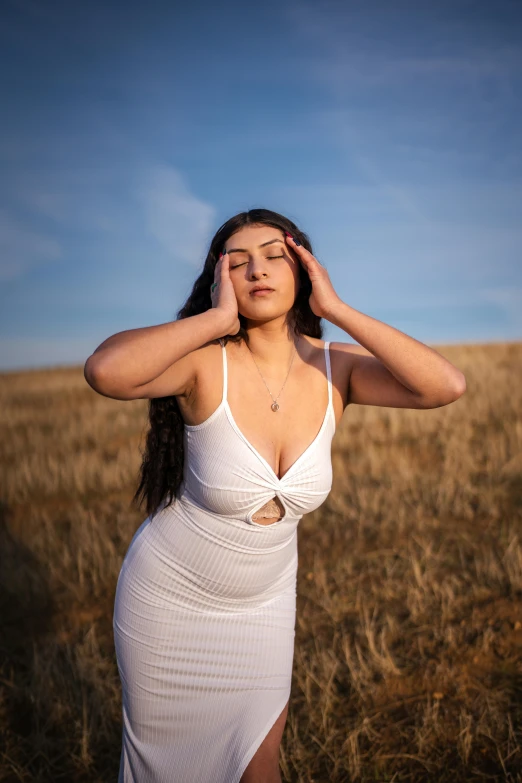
<box><xmin>225</xmin><ymin>226</ymin><xmax>300</xmax><ymax>321</ymax></box>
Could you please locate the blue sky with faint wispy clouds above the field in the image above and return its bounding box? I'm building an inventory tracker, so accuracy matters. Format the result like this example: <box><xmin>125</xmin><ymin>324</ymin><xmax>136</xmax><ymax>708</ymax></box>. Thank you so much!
<box><xmin>0</xmin><ymin>0</ymin><xmax>522</xmax><ymax>369</ymax></box>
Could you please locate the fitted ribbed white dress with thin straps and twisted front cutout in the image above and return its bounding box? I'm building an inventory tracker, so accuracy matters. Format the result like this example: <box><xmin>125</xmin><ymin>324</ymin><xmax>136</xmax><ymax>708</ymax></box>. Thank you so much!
<box><xmin>113</xmin><ymin>341</ymin><xmax>335</xmax><ymax>783</ymax></box>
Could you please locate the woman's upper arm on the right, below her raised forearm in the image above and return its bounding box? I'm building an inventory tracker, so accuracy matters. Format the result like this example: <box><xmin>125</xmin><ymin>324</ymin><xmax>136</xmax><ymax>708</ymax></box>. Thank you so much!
<box><xmin>336</xmin><ymin>343</ymin><xmax>433</xmax><ymax>408</ymax></box>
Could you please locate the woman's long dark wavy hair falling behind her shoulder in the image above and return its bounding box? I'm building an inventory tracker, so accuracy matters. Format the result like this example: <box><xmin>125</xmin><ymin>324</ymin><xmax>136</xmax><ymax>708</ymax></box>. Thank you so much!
<box><xmin>132</xmin><ymin>209</ymin><xmax>323</xmax><ymax>516</ymax></box>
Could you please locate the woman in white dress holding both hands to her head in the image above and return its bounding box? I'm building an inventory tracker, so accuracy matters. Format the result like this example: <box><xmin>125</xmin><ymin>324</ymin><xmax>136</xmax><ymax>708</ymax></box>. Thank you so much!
<box><xmin>85</xmin><ymin>209</ymin><xmax>465</xmax><ymax>783</ymax></box>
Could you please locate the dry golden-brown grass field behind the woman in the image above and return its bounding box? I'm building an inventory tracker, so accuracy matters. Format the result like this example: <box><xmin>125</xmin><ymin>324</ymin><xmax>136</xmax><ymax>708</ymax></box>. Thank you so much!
<box><xmin>0</xmin><ymin>343</ymin><xmax>522</xmax><ymax>783</ymax></box>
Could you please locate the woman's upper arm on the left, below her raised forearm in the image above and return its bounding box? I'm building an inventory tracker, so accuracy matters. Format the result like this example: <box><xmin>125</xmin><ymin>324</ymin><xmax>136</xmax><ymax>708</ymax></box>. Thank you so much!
<box><xmin>85</xmin><ymin>350</ymin><xmax>200</xmax><ymax>400</ymax></box>
